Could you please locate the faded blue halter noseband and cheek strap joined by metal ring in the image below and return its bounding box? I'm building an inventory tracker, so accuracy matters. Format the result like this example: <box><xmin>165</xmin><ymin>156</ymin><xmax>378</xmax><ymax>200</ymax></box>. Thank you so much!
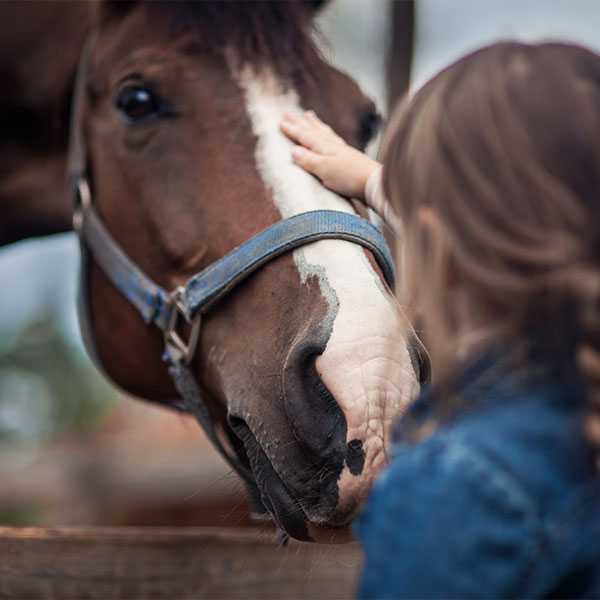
<box><xmin>75</xmin><ymin>178</ymin><xmax>394</xmax><ymax>364</ymax></box>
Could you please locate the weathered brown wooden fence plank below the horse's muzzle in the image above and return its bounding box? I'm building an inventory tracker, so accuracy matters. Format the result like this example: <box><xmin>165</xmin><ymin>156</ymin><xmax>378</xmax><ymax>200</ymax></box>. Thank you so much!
<box><xmin>0</xmin><ymin>527</ymin><xmax>362</xmax><ymax>599</ymax></box>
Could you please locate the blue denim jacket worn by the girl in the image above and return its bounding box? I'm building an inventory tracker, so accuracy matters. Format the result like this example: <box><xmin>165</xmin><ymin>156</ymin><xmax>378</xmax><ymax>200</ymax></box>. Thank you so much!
<box><xmin>355</xmin><ymin>353</ymin><xmax>600</xmax><ymax>598</ymax></box>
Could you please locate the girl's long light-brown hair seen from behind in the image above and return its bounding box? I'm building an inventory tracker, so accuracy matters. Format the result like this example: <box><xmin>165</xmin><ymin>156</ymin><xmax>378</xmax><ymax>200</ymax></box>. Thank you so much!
<box><xmin>384</xmin><ymin>43</ymin><xmax>600</xmax><ymax>464</ymax></box>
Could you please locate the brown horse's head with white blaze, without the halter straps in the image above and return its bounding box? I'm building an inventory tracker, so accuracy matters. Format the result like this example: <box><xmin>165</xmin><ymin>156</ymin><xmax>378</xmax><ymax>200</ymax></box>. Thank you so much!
<box><xmin>76</xmin><ymin>2</ymin><xmax>418</xmax><ymax>541</ymax></box>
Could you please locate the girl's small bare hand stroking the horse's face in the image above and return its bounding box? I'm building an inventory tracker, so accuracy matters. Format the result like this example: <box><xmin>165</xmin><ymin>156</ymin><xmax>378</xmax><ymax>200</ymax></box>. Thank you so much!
<box><xmin>280</xmin><ymin>110</ymin><xmax>381</xmax><ymax>201</ymax></box>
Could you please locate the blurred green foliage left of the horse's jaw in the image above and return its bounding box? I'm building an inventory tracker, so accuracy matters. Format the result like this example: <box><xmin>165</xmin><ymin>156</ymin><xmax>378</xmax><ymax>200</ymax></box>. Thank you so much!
<box><xmin>0</xmin><ymin>312</ymin><xmax>119</xmax><ymax>443</ymax></box>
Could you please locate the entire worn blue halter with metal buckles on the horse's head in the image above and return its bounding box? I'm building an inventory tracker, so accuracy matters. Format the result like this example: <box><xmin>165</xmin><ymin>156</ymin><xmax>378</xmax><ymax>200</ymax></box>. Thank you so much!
<box><xmin>68</xmin><ymin>32</ymin><xmax>394</xmax><ymax>484</ymax></box>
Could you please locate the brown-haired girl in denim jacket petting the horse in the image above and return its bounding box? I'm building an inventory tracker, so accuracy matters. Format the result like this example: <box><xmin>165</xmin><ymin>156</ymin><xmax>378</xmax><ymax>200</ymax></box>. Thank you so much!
<box><xmin>281</xmin><ymin>43</ymin><xmax>600</xmax><ymax>598</ymax></box>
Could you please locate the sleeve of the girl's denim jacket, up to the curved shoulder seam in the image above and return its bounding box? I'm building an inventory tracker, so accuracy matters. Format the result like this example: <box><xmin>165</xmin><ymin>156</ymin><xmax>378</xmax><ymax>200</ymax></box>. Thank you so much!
<box><xmin>356</xmin><ymin>424</ymin><xmax>540</xmax><ymax>598</ymax></box>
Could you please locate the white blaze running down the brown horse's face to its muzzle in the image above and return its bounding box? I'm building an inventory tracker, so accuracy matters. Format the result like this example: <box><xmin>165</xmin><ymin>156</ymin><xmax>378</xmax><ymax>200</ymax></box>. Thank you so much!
<box><xmin>238</xmin><ymin>66</ymin><xmax>418</xmax><ymax>510</ymax></box>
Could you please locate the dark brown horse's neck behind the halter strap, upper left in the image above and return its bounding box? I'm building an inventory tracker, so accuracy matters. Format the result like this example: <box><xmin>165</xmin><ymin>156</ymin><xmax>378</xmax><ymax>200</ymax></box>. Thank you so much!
<box><xmin>0</xmin><ymin>0</ymin><xmax>94</xmax><ymax>245</ymax></box>
